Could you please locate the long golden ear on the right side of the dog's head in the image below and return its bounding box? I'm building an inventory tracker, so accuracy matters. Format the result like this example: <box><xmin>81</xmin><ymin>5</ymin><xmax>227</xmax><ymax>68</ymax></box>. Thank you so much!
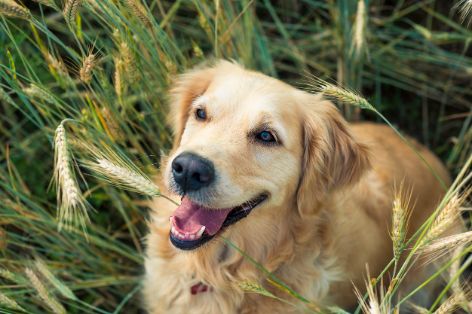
<box><xmin>297</xmin><ymin>95</ymin><xmax>370</xmax><ymax>215</ymax></box>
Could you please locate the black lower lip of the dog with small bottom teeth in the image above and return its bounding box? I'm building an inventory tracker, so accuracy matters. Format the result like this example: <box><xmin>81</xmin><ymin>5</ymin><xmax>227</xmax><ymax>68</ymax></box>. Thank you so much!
<box><xmin>169</xmin><ymin>193</ymin><xmax>268</xmax><ymax>250</ymax></box>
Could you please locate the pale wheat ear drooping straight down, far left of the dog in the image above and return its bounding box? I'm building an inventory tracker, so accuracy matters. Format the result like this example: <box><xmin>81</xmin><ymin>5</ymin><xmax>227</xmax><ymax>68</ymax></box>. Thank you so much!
<box><xmin>54</xmin><ymin>120</ymin><xmax>89</xmax><ymax>231</ymax></box>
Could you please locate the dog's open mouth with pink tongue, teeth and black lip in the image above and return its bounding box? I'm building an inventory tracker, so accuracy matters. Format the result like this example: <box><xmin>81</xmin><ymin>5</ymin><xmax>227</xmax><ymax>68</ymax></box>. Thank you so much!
<box><xmin>169</xmin><ymin>194</ymin><xmax>267</xmax><ymax>250</ymax></box>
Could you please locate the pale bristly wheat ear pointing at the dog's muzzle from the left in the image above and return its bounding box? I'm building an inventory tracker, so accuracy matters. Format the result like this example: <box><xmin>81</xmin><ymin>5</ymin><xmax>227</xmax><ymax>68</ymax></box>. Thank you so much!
<box><xmin>87</xmin><ymin>158</ymin><xmax>160</xmax><ymax>196</ymax></box>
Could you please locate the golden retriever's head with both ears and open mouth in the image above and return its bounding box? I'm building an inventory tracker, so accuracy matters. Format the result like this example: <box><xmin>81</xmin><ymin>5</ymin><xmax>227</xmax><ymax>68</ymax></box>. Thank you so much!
<box><xmin>164</xmin><ymin>61</ymin><xmax>368</xmax><ymax>250</ymax></box>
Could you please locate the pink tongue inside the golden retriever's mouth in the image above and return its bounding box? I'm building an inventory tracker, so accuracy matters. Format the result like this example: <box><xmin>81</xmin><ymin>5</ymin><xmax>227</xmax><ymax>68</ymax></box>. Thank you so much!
<box><xmin>173</xmin><ymin>196</ymin><xmax>232</xmax><ymax>235</ymax></box>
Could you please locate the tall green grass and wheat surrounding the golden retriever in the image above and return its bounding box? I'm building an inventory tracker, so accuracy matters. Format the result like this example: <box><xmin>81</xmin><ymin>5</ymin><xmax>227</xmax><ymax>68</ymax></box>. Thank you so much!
<box><xmin>0</xmin><ymin>0</ymin><xmax>472</xmax><ymax>313</ymax></box>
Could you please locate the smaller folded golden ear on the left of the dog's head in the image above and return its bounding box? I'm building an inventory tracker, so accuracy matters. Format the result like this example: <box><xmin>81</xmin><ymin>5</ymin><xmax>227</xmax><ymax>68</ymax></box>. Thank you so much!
<box><xmin>169</xmin><ymin>67</ymin><xmax>215</xmax><ymax>148</ymax></box>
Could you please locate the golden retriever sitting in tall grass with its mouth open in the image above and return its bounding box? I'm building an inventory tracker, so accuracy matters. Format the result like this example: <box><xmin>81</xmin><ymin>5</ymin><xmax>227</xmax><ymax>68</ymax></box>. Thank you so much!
<box><xmin>144</xmin><ymin>61</ymin><xmax>449</xmax><ymax>314</ymax></box>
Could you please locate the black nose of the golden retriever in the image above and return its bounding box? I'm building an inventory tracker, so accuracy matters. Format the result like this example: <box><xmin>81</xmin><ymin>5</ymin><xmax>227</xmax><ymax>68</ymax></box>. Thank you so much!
<box><xmin>172</xmin><ymin>153</ymin><xmax>215</xmax><ymax>193</ymax></box>
